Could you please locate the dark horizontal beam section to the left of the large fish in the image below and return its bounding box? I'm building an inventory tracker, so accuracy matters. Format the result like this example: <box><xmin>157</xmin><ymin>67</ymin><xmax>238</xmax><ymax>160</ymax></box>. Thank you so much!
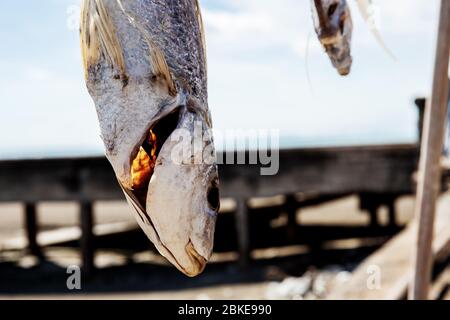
<box><xmin>0</xmin><ymin>157</ymin><xmax>123</xmax><ymax>202</ymax></box>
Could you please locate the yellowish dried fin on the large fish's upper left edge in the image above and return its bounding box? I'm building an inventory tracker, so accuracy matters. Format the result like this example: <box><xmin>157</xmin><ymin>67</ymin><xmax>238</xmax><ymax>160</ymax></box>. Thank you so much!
<box><xmin>80</xmin><ymin>0</ymin><xmax>126</xmax><ymax>76</ymax></box>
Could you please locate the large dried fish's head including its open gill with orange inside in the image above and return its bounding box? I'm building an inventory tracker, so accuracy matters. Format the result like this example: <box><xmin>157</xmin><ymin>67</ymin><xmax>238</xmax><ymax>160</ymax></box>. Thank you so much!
<box><xmin>119</xmin><ymin>98</ymin><xmax>220</xmax><ymax>277</ymax></box>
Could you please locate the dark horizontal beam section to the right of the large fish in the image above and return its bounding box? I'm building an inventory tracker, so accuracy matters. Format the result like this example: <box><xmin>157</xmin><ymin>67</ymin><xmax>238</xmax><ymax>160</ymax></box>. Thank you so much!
<box><xmin>219</xmin><ymin>145</ymin><xmax>418</xmax><ymax>198</ymax></box>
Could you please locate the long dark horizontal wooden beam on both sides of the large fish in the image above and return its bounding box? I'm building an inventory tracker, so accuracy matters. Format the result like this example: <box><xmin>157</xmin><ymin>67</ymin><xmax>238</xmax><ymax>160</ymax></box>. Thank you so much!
<box><xmin>0</xmin><ymin>144</ymin><xmax>418</xmax><ymax>202</ymax></box>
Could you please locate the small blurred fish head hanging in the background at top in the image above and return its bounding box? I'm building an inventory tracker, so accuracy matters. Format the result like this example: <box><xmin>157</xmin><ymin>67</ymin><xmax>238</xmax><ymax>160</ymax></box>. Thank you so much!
<box><xmin>311</xmin><ymin>0</ymin><xmax>353</xmax><ymax>76</ymax></box>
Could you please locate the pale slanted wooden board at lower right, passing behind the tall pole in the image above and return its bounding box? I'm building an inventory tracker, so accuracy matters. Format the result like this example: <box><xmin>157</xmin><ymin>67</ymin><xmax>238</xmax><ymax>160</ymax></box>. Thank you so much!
<box><xmin>328</xmin><ymin>194</ymin><xmax>450</xmax><ymax>300</ymax></box>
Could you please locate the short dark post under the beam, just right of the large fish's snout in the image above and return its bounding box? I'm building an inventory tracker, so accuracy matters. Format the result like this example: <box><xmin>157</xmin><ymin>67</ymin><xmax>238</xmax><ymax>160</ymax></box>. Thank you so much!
<box><xmin>235</xmin><ymin>198</ymin><xmax>250</xmax><ymax>268</ymax></box>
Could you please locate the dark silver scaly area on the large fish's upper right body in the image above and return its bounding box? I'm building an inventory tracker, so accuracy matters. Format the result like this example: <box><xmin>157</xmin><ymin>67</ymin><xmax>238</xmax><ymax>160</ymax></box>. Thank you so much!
<box><xmin>123</xmin><ymin>0</ymin><xmax>207</xmax><ymax>102</ymax></box>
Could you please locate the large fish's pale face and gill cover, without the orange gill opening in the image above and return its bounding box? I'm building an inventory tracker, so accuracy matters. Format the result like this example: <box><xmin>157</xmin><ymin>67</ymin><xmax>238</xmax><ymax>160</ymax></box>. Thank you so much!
<box><xmin>142</xmin><ymin>102</ymin><xmax>220</xmax><ymax>276</ymax></box>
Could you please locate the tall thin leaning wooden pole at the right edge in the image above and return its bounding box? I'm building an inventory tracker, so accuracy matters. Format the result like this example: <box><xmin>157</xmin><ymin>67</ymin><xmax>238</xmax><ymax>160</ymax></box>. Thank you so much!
<box><xmin>409</xmin><ymin>0</ymin><xmax>450</xmax><ymax>300</ymax></box>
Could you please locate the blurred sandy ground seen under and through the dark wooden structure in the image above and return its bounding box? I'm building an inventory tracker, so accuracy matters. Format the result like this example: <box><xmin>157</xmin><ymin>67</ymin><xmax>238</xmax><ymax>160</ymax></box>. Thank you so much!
<box><xmin>0</xmin><ymin>197</ymin><xmax>426</xmax><ymax>299</ymax></box>
